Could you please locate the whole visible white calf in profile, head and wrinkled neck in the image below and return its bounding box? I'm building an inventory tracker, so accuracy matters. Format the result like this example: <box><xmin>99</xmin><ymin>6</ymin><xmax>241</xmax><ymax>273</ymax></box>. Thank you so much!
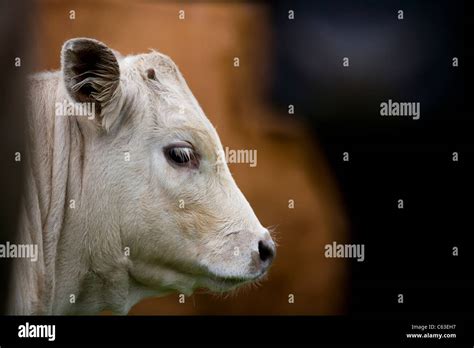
<box><xmin>10</xmin><ymin>38</ymin><xmax>275</xmax><ymax>314</ymax></box>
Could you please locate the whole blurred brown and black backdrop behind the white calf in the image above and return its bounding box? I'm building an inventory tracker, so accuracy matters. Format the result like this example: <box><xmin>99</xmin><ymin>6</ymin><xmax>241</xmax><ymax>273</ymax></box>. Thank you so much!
<box><xmin>2</xmin><ymin>0</ymin><xmax>466</xmax><ymax>315</ymax></box>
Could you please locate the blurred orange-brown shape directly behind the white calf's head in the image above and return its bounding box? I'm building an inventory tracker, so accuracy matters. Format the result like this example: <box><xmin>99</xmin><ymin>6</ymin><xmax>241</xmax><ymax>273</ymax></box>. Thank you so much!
<box><xmin>31</xmin><ymin>0</ymin><xmax>347</xmax><ymax>315</ymax></box>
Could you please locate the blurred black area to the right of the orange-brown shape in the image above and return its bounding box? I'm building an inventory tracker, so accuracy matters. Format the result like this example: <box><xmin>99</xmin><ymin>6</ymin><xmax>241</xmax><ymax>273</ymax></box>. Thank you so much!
<box><xmin>270</xmin><ymin>1</ymin><xmax>474</xmax><ymax>313</ymax></box>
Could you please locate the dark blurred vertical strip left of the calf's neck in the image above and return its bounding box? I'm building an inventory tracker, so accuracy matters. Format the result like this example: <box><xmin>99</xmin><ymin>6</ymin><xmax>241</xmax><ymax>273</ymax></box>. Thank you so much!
<box><xmin>0</xmin><ymin>1</ymin><xmax>34</xmax><ymax>314</ymax></box>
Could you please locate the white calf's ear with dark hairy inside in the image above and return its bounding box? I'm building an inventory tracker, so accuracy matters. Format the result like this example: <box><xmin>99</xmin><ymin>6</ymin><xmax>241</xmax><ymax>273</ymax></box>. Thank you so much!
<box><xmin>61</xmin><ymin>38</ymin><xmax>120</xmax><ymax>128</ymax></box>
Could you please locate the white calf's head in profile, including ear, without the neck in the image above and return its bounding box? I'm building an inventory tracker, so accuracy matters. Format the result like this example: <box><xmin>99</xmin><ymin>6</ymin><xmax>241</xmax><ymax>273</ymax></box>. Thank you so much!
<box><xmin>62</xmin><ymin>39</ymin><xmax>275</xmax><ymax>293</ymax></box>
